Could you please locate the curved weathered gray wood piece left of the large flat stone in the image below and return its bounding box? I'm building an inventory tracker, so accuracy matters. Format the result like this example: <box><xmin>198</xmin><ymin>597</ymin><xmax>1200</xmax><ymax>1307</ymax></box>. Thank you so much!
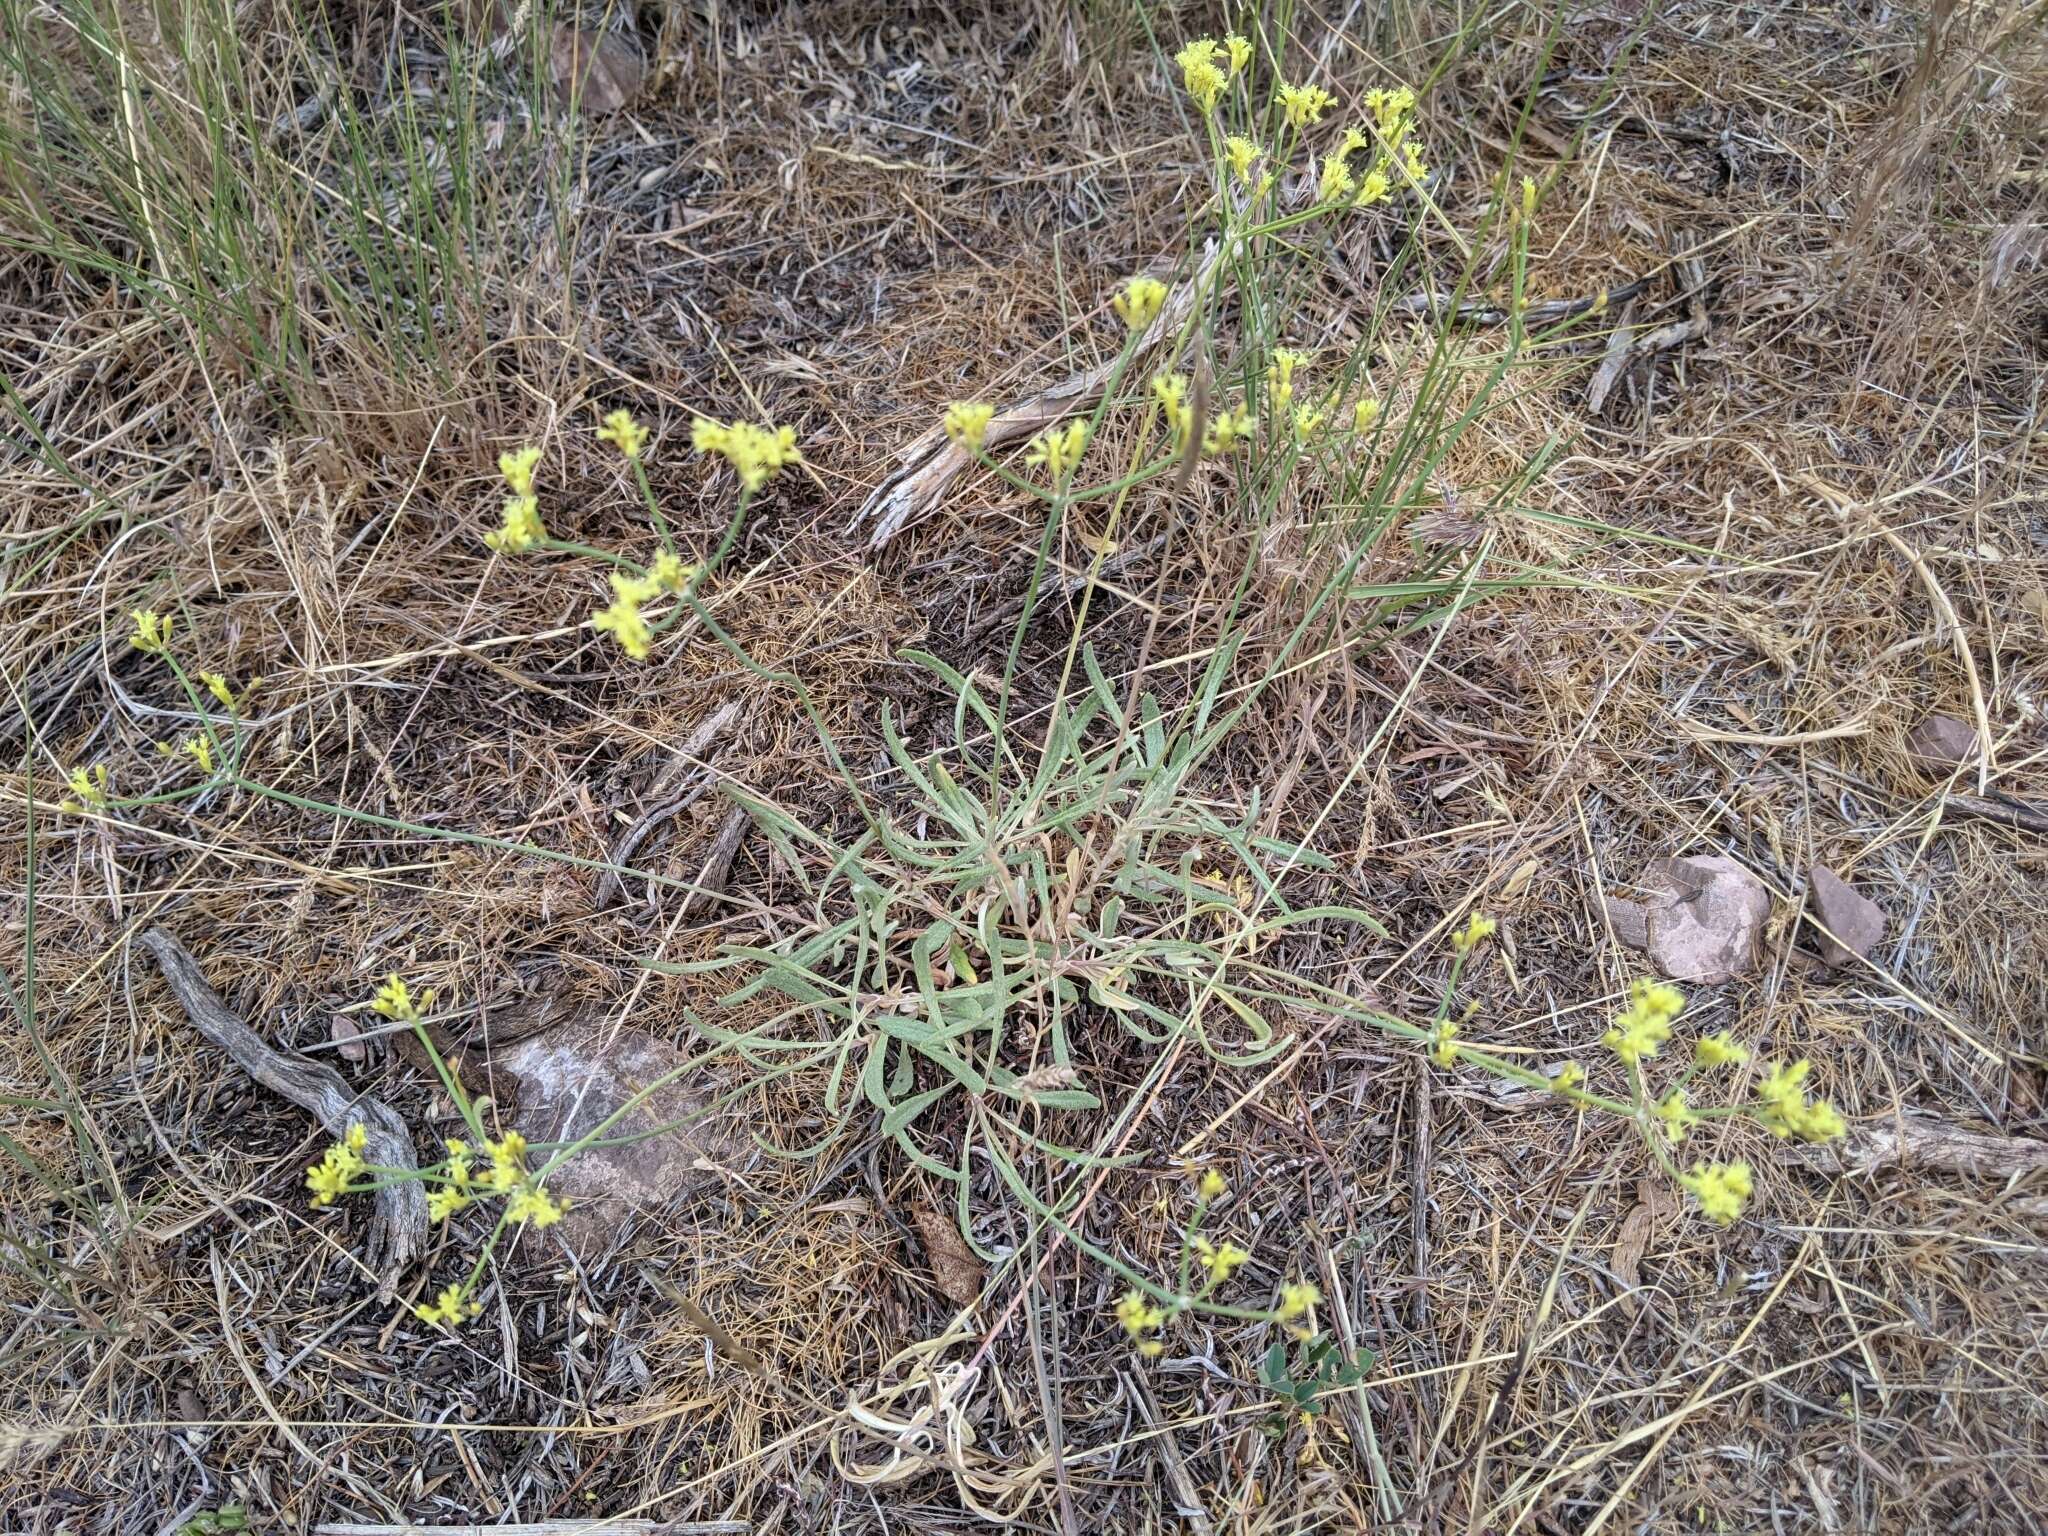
<box><xmin>135</xmin><ymin>928</ymin><xmax>428</xmax><ymax>1300</ymax></box>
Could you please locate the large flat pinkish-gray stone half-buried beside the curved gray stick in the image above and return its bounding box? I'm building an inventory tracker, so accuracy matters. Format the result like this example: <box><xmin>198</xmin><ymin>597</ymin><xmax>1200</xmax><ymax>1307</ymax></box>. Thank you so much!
<box><xmin>503</xmin><ymin>1014</ymin><xmax>752</xmax><ymax>1255</ymax></box>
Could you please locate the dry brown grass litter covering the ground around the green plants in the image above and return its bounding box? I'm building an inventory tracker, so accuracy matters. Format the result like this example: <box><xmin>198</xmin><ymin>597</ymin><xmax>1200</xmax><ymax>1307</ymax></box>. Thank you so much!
<box><xmin>0</xmin><ymin>2</ymin><xmax>2048</xmax><ymax>1534</ymax></box>
